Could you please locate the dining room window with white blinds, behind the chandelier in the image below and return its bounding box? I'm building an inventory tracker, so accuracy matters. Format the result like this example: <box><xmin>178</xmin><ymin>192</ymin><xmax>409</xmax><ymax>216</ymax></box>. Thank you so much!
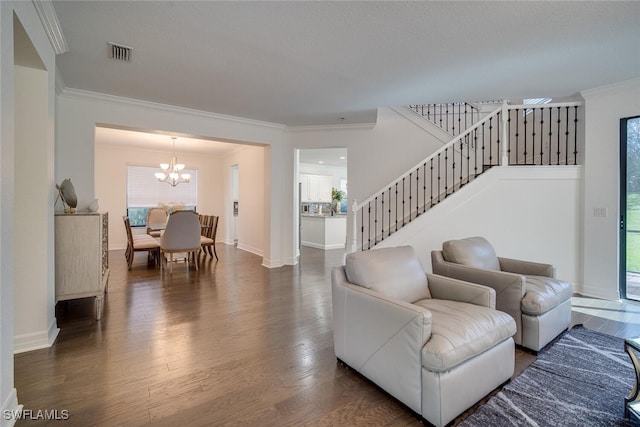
<box><xmin>127</xmin><ymin>166</ymin><xmax>198</xmax><ymax>227</ymax></box>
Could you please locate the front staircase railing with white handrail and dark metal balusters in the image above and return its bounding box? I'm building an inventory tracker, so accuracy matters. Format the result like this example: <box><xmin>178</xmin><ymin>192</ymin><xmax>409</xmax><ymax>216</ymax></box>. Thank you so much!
<box><xmin>350</xmin><ymin>102</ymin><xmax>581</xmax><ymax>252</ymax></box>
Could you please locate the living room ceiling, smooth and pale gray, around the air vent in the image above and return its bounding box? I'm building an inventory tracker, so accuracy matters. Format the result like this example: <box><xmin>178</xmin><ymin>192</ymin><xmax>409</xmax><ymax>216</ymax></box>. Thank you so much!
<box><xmin>54</xmin><ymin>1</ymin><xmax>640</xmax><ymax>126</ymax></box>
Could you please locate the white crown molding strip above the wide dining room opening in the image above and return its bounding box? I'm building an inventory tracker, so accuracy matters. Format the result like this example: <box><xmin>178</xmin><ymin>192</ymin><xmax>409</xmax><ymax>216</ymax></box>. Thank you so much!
<box><xmin>60</xmin><ymin>87</ymin><xmax>287</xmax><ymax>131</ymax></box>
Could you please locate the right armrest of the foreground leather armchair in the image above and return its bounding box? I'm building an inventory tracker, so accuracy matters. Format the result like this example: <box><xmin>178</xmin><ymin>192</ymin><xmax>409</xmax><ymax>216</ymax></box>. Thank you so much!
<box><xmin>427</xmin><ymin>274</ymin><xmax>496</xmax><ymax>309</ymax></box>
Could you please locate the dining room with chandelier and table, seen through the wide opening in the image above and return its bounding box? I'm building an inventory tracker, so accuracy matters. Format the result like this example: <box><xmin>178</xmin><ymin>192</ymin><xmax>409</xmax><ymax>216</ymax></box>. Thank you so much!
<box><xmin>94</xmin><ymin>126</ymin><xmax>264</xmax><ymax>272</ymax></box>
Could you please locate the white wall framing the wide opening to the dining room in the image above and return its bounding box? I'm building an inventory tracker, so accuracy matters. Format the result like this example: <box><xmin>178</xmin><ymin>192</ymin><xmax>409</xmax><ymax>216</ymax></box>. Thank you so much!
<box><xmin>56</xmin><ymin>89</ymin><xmax>295</xmax><ymax>267</ymax></box>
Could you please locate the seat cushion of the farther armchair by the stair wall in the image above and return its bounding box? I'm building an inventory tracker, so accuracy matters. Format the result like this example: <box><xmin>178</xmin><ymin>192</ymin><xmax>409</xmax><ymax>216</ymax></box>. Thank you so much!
<box><xmin>520</xmin><ymin>276</ymin><xmax>573</xmax><ymax>316</ymax></box>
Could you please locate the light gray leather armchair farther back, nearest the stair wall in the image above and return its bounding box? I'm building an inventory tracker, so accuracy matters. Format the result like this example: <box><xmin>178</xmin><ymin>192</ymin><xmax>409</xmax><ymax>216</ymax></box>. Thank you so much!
<box><xmin>431</xmin><ymin>237</ymin><xmax>573</xmax><ymax>352</ymax></box>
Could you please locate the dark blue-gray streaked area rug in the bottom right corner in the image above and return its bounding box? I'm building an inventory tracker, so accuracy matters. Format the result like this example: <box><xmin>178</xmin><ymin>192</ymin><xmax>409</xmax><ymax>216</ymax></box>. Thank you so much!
<box><xmin>459</xmin><ymin>326</ymin><xmax>635</xmax><ymax>427</ymax></box>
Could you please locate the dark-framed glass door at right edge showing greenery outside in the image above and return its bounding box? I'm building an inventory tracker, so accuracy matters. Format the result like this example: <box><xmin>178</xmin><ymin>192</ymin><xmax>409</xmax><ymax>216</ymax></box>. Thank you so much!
<box><xmin>619</xmin><ymin>116</ymin><xmax>640</xmax><ymax>301</ymax></box>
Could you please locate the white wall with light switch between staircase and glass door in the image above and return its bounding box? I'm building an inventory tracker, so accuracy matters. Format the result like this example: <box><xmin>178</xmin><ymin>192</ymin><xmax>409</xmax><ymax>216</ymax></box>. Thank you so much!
<box><xmin>581</xmin><ymin>79</ymin><xmax>640</xmax><ymax>299</ymax></box>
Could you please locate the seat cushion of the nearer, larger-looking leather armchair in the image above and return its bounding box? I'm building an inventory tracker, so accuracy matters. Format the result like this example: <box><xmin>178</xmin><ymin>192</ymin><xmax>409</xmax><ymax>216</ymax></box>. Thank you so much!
<box><xmin>415</xmin><ymin>299</ymin><xmax>516</xmax><ymax>372</ymax></box>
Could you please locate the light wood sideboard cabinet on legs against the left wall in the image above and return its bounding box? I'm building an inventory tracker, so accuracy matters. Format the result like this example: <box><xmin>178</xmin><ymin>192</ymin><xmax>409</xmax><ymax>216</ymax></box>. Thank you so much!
<box><xmin>55</xmin><ymin>213</ymin><xmax>109</xmax><ymax>320</ymax></box>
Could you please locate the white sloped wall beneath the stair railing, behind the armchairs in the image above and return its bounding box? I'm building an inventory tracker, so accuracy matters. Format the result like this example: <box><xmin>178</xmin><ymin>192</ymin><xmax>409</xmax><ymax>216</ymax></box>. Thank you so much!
<box><xmin>379</xmin><ymin>166</ymin><xmax>582</xmax><ymax>289</ymax></box>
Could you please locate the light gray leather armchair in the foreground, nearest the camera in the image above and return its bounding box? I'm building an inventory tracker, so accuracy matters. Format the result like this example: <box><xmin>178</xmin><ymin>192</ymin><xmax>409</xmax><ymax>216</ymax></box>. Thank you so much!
<box><xmin>331</xmin><ymin>246</ymin><xmax>516</xmax><ymax>426</ymax></box>
